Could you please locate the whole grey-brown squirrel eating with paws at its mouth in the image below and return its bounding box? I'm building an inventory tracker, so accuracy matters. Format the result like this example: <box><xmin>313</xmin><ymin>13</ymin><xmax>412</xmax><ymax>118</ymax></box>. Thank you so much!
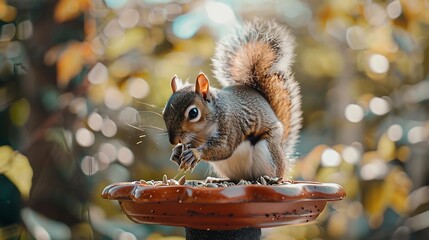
<box><xmin>163</xmin><ymin>19</ymin><xmax>302</xmax><ymax>180</ymax></box>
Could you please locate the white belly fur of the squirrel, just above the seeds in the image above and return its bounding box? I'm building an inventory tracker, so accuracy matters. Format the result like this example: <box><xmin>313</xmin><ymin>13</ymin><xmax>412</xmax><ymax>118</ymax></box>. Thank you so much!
<box><xmin>209</xmin><ymin>140</ymin><xmax>276</xmax><ymax>179</ymax></box>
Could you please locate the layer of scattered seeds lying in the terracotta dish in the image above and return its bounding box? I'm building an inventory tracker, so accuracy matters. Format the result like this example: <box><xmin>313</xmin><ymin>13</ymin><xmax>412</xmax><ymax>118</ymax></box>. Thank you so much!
<box><xmin>139</xmin><ymin>175</ymin><xmax>291</xmax><ymax>188</ymax></box>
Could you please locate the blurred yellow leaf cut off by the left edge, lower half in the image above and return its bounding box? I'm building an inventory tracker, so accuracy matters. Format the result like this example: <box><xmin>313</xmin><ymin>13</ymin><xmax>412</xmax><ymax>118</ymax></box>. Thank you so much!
<box><xmin>0</xmin><ymin>146</ymin><xmax>33</xmax><ymax>198</ymax></box>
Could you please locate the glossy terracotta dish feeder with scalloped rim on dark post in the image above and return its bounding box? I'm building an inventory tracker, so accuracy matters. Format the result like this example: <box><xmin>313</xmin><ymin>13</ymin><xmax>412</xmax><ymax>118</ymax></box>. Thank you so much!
<box><xmin>102</xmin><ymin>177</ymin><xmax>345</xmax><ymax>239</ymax></box>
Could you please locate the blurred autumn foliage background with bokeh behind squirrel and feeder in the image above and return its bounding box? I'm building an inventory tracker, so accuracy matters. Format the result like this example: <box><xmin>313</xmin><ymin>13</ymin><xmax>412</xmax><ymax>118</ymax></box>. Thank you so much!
<box><xmin>0</xmin><ymin>0</ymin><xmax>429</xmax><ymax>240</ymax></box>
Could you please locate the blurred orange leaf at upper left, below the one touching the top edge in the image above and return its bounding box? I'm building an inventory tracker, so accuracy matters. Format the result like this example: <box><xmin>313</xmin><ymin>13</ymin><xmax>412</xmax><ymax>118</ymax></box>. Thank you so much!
<box><xmin>57</xmin><ymin>43</ymin><xmax>83</xmax><ymax>87</ymax></box>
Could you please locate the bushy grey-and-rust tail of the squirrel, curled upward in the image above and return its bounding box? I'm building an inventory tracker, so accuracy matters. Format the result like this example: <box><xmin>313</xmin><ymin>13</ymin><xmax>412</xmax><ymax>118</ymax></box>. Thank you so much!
<box><xmin>212</xmin><ymin>20</ymin><xmax>302</xmax><ymax>157</ymax></box>
